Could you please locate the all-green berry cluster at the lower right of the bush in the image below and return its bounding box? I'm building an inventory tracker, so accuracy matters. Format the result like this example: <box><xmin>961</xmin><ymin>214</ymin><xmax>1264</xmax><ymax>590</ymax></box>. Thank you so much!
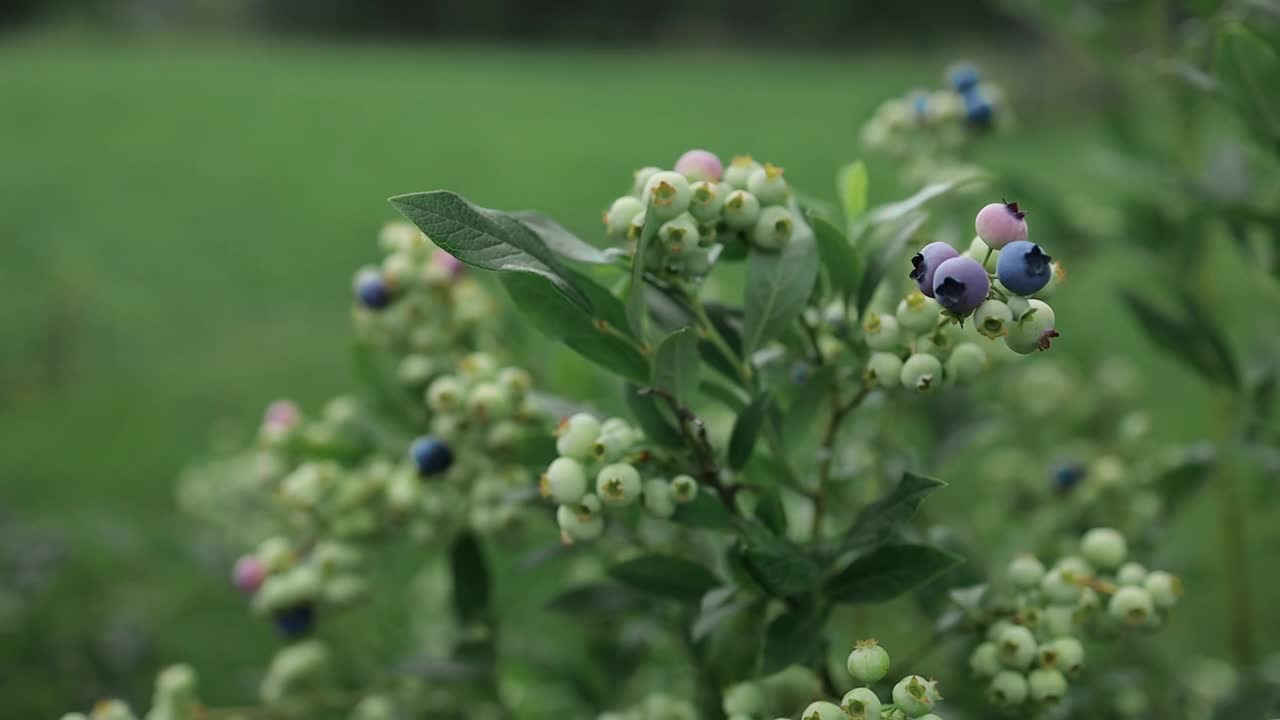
<box><xmin>969</xmin><ymin>528</ymin><xmax>1183</xmax><ymax>707</ymax></box>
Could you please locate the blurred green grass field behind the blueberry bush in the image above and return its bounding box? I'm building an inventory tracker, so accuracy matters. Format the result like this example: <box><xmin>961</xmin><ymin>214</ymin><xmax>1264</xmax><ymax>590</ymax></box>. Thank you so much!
<box><xmin>0</xmin><ymin>30</ymin><xmax>1269</xmax><ymax>711</ymax></box>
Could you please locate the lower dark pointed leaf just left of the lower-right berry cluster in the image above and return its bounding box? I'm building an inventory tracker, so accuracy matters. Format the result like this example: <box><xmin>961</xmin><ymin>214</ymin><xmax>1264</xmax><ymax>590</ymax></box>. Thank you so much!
<box><xmin>826</xmin><ymin>544</ymin><xmax>960</xmax><ymax>603</ymax></box>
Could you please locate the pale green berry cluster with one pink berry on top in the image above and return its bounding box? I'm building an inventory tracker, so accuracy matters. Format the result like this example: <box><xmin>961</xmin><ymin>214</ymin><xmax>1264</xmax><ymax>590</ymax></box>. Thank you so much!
<box><xmin>604</xmin><ymin>150</ymin><xmax>797</xmax><ymax>279</ymax></box>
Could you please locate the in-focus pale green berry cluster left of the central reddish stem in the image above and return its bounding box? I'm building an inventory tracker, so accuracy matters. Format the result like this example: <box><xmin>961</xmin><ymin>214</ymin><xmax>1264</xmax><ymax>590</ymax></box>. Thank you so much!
<box><xmin>539</xmin><ymin>413</ymin><xmax>698</xmax><ymax>544</ymax></box>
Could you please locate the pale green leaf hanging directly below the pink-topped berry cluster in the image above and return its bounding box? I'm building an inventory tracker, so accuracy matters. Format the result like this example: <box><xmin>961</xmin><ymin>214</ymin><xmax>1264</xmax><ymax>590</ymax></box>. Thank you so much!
<box><xmin>742</xmin><ymin>223</ymin><xmax>818</xmax><ymax>357</ymax></box>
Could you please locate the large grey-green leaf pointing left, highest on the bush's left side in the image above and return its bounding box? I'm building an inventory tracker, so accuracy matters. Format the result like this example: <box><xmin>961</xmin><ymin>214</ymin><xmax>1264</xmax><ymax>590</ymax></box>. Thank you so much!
<box><xmin>390</xmin><ymin>190</ymin><xmax>591</xmax><ymax>313</ymax></box>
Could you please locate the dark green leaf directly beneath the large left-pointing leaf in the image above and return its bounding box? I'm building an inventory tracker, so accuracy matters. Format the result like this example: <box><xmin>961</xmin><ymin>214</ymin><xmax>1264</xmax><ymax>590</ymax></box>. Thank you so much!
<box><xmin>502</xmin><ymin>272</ymin><xmax>649</xmax><ymax>383</ymax></box>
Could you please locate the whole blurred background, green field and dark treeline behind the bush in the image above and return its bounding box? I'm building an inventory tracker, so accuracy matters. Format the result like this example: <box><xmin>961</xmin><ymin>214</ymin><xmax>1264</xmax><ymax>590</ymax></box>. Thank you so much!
<box><xmin>0</xmin><ymin>0</ymin><xmax>1280</xmax><ymax>717</ymax></box>
